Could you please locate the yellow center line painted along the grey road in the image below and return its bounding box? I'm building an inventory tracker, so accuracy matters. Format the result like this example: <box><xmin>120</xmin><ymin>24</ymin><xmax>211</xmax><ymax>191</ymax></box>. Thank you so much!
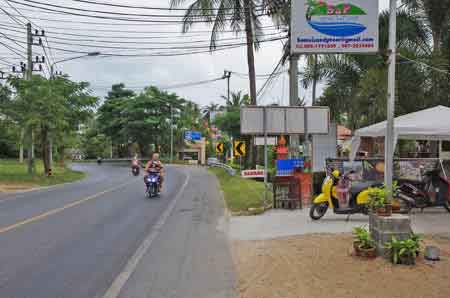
<box><xmin>0</xmin><ymin>180</ymin><xmax>136</xmax><ymax>234</ymax></box>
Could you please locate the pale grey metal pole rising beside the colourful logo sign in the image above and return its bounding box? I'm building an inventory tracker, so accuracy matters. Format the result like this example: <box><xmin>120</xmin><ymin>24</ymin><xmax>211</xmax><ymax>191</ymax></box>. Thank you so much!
<box><xmin>384</xmin><ymin>0</ymin><xmax>397</xmax><ymax>198</ymax></box>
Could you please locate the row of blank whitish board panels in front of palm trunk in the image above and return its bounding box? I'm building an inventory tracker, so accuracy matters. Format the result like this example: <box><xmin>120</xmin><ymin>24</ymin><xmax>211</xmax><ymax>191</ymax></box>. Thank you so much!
<box><xmin>241</xmin><ymin>107</ymin><xmax>330</xmax><ymax>136</ymax></box>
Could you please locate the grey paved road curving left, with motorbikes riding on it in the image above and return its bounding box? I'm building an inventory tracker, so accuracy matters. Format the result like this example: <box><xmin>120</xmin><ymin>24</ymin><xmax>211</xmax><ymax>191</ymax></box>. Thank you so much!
<box><xmin>0</xmin><ymin>165</ymin><xmax>234</xmax><ymax>298</ymax></box>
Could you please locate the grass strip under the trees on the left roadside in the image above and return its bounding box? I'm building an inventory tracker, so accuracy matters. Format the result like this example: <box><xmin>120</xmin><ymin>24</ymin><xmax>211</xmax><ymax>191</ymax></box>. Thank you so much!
<box><xmin>0</xmin><ymin>159</ymin><xmax>86</xmax><ymax>188</ymax></box>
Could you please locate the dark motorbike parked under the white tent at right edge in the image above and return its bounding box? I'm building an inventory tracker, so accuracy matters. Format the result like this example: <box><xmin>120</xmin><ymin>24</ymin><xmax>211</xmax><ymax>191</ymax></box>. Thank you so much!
<box><xmin>398</xmin><ymin>169</ymin><xmax>450</xmax><ymax>212</ymax></box>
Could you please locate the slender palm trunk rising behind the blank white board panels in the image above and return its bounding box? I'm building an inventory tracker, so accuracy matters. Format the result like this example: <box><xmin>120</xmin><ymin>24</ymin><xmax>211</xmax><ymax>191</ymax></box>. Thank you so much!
<box><xmin>244</xmin><ymin>0</ymin><xmax>258</xmax><ymax>167</ymax></box>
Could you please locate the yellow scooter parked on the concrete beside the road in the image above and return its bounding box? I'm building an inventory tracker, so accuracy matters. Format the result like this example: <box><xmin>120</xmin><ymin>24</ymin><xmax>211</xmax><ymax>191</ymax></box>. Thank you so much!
<box><xmin>309</xmin><ymin>170</ymin><xmax>382</xmax><ymax>220</ymax></box>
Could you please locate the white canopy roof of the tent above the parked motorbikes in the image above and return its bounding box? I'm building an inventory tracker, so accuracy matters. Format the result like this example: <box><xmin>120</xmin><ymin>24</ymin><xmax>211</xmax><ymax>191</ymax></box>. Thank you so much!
<box><xmin>355</xmin><ymin>106</ymin><xmax>450</xmax><ymax>140</ymax></box>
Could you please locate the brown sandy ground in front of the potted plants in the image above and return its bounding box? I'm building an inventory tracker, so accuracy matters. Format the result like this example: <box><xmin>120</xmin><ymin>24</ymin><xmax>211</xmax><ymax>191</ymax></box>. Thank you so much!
<box><xmin>232</xmin><ymin>234</ymin><xmax>450</xmax><ymax>298</ymax></box>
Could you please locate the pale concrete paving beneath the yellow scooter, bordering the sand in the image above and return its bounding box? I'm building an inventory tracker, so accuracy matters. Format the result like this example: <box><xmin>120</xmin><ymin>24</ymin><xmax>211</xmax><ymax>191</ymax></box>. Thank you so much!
<box><xmin>228</xmin><ymin>208</ymin><xmax>450</xmax><ymax>240</ymax></box>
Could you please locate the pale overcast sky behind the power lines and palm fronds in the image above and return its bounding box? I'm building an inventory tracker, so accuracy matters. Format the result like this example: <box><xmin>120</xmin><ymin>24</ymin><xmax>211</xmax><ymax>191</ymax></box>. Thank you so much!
<box><xmin>0</xmin><ymin>0</ymin><xmax>389</xmax><ymax>106</ymax></box>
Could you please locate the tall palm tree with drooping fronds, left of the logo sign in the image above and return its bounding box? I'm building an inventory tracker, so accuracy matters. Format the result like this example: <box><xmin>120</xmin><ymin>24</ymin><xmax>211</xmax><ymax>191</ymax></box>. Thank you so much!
<box><xmin>170</xmin><ymin>0</ymin><xmax>262</xmax><ymax>105</ymax></box>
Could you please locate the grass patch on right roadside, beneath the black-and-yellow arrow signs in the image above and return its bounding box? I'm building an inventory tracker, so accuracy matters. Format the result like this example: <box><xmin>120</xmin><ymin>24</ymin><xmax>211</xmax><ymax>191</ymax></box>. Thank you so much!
<box><xmin>209</xmin><ymin>168</ymin><xmax>272</xmax><ymax>214</ymax></box>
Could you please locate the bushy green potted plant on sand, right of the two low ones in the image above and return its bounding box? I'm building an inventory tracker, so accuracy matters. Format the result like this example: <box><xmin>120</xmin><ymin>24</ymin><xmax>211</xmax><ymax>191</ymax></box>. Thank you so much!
<box><xmin>386</xmin><ymin>234</ymin><xmax>422</xmax><ymax>266</ymax></box>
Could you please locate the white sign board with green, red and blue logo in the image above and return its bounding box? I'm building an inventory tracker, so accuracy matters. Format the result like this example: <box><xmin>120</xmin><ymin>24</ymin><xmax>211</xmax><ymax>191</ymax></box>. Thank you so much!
<box><xmin>291</xmin><ymin>0</ymin><xmax>378</xmax><ymax>54</ymax></box>
